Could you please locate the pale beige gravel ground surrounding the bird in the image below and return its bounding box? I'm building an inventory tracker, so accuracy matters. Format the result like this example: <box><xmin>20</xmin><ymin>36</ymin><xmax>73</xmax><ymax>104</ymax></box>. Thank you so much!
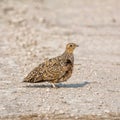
<box><xmin>0</xmin><ymin>0</ymin><xmax>120</xmax><ymax>120</ymax></box>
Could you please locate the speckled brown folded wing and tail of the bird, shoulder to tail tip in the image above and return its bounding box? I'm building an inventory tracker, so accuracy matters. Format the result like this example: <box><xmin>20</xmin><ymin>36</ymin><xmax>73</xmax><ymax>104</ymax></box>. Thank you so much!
<box><xmin>24</xmin><ymin>57</ymin><xmax>71</xmax><ymax>83</ymax></box>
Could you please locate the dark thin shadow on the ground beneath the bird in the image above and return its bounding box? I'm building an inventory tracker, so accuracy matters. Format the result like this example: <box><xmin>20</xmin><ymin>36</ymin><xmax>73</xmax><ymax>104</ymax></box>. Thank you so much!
<box><xmin>25</xmin><ymin>81</ymin><xmax>90</xmax><ymax>88</ymax></box>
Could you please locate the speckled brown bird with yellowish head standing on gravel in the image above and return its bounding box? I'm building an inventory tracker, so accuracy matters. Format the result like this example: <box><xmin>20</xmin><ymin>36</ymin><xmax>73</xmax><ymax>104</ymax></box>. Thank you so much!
<box><xmin>23</xmin><ymin>43</ymin><xmax>78</xmax><ymax>88</ymax></box>
